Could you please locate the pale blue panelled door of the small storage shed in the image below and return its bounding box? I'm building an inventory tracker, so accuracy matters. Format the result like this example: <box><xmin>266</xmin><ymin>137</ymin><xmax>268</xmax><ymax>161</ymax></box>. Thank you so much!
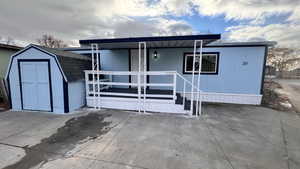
<box><xmin>20</xmin><ymin>61</ymin><xmax>51</xmax><ymax>111</ymax></box>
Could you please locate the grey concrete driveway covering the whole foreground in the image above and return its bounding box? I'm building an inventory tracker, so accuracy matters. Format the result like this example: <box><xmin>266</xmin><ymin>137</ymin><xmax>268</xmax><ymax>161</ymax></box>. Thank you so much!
<box><xmin>0</xmin><ymin>104</ymin><xmax>300</xmax><ymax>169</ymax></box>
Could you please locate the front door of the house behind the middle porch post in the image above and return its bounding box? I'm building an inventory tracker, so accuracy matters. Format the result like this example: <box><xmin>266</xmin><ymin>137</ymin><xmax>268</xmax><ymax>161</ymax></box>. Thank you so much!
<box><xmin>131</xmin><ymin>49</ymin><xmax>144</xmax><ymax>86</ymax></box>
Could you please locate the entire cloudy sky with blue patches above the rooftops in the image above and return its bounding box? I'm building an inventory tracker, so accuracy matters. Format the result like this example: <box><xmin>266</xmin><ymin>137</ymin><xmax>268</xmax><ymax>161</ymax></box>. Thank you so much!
<box><xmin>0</xmin><ymin>0</ymin><xmax>300</xmax><ymax>47</ymax></box>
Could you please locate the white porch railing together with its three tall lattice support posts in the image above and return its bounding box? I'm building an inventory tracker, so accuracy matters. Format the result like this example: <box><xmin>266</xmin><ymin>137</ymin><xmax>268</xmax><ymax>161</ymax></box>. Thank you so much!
<box><xmin>85</xmin><ymin>40</ymin><xmax>203</xmax><ymax>116</ymax></box>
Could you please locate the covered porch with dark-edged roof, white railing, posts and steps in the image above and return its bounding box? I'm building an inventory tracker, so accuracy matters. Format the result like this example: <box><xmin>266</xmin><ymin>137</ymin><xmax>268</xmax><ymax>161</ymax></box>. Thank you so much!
<box><xmin>81</xmin><ymin>35</ymin><xmax>219</xmax><ymax>116</ymax></box>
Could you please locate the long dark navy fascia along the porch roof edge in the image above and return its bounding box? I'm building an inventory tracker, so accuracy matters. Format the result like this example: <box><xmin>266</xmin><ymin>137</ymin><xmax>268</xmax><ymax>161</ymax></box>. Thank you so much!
<box><xmin>79</xmin><ymin>34</ymin><xmax>221</xmax><ymax>44</ymax></box>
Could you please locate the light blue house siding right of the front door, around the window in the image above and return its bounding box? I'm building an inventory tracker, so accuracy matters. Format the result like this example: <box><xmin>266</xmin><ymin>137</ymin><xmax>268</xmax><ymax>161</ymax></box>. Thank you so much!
<box><xmin>149</xmin><ymin>47</ymin><xmax>265</xmax><ymax>94</ymax></box>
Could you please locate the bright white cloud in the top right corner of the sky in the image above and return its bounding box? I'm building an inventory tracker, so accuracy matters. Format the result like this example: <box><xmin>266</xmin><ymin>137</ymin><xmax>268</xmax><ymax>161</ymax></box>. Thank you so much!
<box><xmin>191</xmin><ymin>0</ymin><xmax>300</xmax><ymax>20</ymax></box>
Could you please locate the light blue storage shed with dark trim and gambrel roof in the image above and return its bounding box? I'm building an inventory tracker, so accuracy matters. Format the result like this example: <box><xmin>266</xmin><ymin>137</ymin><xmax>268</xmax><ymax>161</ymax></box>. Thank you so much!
<box><xmin>6</xmin><ymin>45</ymin><xmax>91</xmax><ymax>113</ymax></box>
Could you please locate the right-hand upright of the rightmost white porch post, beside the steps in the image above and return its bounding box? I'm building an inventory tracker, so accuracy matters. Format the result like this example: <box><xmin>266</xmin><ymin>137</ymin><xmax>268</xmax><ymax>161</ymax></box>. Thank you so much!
<box><xmin>196</xmin><ymin>40</ymin><xmax>203</xmax><ymax>116</ymax></box>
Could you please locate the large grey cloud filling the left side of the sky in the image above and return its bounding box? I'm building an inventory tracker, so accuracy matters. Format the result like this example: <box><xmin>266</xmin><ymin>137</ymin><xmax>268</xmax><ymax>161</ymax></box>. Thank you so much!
<box><xmin>0</xmin><ymin>0</ymin><xmax>192</xmax><ymax>45</ymax></box>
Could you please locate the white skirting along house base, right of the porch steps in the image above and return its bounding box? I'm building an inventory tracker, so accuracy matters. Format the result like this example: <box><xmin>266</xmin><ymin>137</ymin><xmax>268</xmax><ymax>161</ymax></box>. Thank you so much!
<box><xmin>182</xmin><ymin>92</ymin><xmax>262</xmax><ymax>105</ymax></box>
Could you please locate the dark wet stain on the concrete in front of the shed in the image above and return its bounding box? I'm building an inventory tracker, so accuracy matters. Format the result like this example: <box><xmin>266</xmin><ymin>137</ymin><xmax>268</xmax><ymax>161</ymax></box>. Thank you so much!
<box><xmin>4</xmin><ymin>113</ymin><xmax>111</xmax><ymax>169</ymax></box>
